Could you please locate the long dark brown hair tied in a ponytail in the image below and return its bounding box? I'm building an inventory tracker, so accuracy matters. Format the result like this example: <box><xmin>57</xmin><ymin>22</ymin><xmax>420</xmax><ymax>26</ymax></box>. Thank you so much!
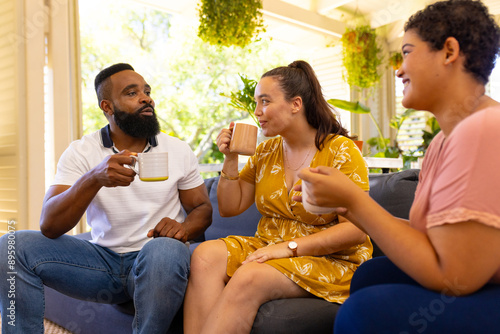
<box><xmin>262</xmin><ymin>60</ymin><xmax>351</xmax><ymax>150</ymax></box>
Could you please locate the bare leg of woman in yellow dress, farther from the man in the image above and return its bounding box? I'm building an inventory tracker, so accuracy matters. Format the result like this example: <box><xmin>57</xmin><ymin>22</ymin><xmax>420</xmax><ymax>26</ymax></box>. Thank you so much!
<box><xmin>202</xmin><ymin>262</ymin><xmax>311</xmax><ymax>334</ymax></box>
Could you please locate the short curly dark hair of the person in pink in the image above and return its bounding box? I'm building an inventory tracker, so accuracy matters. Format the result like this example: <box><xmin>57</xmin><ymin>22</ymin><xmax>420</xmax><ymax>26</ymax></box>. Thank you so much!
<box><xmin>404</xmin><ymin>0</ymin><xmax>500</xmax><ymax>84</ymax></box>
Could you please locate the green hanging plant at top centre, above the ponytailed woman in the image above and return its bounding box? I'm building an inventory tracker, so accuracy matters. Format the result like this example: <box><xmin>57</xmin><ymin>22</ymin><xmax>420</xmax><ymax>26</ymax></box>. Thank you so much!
<box><xmin>198</xmin><ymin>0</ymin><xmax>265</xmax><ymax>47</ymax></box>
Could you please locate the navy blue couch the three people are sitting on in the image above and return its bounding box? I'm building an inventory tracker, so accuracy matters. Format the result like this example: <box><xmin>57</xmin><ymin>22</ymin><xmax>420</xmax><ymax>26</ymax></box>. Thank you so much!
<box><xmin>45</xmin><ymin>170</ymin><xmax>418</xmax><ymax>334</ymax></box>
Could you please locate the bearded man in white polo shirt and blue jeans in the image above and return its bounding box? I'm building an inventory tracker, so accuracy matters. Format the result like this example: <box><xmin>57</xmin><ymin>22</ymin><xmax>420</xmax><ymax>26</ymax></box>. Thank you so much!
<box><xmin>0</xmin><ymin>63</ymin><xmax>212</xmax><ymax>334</ymax></box>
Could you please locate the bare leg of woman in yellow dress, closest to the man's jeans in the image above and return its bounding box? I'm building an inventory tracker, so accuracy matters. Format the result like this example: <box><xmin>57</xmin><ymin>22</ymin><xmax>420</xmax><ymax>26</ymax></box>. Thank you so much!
<box><xmin>184</xmin><ymin>240</ymin><xmax>229</xmax><ymax>334</ymax></box>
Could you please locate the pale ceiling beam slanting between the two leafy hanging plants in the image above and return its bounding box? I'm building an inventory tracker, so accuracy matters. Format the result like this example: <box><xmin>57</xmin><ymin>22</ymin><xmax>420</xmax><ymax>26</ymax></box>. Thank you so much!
<box><xmin>263</xmin><ymin>0</ymin><xmax>345</xmax><ymax>37</ymax></box>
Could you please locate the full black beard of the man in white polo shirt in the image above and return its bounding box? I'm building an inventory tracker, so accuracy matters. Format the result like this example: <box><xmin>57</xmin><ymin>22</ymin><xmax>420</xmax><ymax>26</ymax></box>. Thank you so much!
<box><xmin>113</xmin><ymin>104</ymin><xmax>160</xmax><ymax>139</ymax></box>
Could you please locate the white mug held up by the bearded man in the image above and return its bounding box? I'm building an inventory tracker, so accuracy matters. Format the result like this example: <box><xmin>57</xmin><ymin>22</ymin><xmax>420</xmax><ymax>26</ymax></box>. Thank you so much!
<box><xmin>130</xmin><ymin>152</ymin><xmax>168</xmax><ymax>182</ymax></box>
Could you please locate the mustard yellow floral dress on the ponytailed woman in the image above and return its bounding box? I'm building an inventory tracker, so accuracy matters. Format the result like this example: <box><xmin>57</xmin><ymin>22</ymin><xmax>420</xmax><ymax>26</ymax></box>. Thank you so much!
<box><xmin>222</xmin><ymin>135</ymin><xmax>373</xmax><ymax>303</ymax></box>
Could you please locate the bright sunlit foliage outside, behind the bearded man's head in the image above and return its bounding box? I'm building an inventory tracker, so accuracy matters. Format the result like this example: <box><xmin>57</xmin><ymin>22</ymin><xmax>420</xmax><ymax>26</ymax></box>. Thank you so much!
<box><xmin>80</xmin><ymin>0</ymin><xmax>296</xmax><ymax>163</ymax></box>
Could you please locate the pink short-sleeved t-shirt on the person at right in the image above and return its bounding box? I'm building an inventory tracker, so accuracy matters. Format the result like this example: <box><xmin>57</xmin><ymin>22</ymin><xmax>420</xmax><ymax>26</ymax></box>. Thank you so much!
<box><xmin>410</xmin><ymin>107</ymin><xmax>500</xmax><ymax>282</ymax></box>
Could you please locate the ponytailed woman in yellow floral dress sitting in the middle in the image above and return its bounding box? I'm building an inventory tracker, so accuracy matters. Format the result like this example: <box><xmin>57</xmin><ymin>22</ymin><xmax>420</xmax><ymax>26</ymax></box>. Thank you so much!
<box><xmin>184</xmin><ymin>61</ymin><xmax>372</xmax><ymax>333</ymax></box>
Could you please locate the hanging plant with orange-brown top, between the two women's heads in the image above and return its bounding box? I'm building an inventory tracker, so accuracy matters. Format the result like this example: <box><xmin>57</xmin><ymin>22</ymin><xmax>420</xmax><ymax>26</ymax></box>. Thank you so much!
<box><xmin>340</xmin><ymin>25</ymin><xmax>382</xmax><ymax>88</ymax></box>
